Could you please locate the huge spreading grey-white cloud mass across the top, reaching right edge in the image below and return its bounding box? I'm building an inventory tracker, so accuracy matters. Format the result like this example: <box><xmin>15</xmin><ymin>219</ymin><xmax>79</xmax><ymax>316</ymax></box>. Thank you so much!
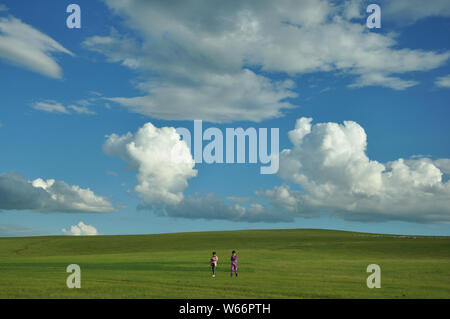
<box><xmin>84</xmin><ymin>0</ymin><xmax>450</xmax><ymax>122</ymax></box>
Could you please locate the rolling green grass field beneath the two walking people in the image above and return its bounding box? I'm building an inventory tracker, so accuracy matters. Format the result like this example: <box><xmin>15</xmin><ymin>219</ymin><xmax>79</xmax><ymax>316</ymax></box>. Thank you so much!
<box><xmin>0</xmin><ymin>229</ymin><xmax>450</xmax><ymax>298</ymax></box>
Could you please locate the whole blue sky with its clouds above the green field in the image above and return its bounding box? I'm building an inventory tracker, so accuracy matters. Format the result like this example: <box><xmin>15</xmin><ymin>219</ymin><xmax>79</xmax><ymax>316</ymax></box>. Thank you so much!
<box><xmin>0</xmin><ymin>0</ymin><xmax>450</xmax><ymax>236</ymax></box>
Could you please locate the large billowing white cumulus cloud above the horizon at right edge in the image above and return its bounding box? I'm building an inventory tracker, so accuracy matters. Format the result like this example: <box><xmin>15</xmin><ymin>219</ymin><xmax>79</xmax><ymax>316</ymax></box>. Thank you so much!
<box><xmin>263</xmin><ymin>118</ymin><xmax>450</xmax><ymax>222</ymax></box>
